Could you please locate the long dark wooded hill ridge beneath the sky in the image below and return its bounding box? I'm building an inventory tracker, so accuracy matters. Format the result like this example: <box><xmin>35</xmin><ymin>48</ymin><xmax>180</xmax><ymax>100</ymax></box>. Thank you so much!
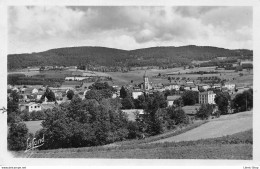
<box><xmin>8</xmin><ymin>45</ymin><xmax>253</xmax><ymax>70</ymax></box>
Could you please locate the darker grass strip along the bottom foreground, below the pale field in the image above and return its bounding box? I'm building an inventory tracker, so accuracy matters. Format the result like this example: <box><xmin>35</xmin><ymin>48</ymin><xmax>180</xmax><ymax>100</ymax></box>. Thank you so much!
<box><xmin>11</xmin><ymin>130</ymin><xmax>253</xmax><ymax>160</ymax></box>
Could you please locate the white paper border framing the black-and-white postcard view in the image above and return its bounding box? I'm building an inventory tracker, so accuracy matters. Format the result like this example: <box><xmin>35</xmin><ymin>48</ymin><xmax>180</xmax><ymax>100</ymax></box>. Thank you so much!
<box><xmin>0</xmin><ymin>0</ymin><xmax>260</xmax><ymax>168</ymax></box>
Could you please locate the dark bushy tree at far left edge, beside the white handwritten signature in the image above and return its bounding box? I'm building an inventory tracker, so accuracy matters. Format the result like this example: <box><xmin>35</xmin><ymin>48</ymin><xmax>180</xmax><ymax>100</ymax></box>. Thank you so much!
<box><xmin>7</xmin><ymin>122</ymin><xmax>28</xmax><ymax>151</ymax></box>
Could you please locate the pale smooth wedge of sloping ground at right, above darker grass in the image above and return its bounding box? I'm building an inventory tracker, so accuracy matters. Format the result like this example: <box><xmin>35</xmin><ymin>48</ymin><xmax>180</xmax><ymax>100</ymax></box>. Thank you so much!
<box><xmin>153</xmin><ymin>111</ymin><xmax>253</xmax><ymax>143</ymax></box>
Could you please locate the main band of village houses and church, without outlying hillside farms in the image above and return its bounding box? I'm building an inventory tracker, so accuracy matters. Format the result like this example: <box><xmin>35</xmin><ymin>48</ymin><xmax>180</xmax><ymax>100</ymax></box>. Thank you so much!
<box><xmin>8</xmin><ymin>70</ymin><xmax>252</xmax><ymax>119</ymax></box>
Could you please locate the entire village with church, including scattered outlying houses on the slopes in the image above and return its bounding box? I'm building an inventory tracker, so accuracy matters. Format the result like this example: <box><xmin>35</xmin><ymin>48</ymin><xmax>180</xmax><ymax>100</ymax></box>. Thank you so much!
<box><xmin>8</xmin><ymin>58</ymin><xmax>253</xmax><ymax>120</ymax></box>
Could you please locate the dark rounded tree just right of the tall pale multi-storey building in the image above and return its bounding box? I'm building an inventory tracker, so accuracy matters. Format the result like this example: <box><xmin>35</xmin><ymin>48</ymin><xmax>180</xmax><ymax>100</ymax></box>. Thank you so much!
<box><xmin>214</xmin><ymin>92</ymin><xmax>231</xmax><ymax>114</ymax></box>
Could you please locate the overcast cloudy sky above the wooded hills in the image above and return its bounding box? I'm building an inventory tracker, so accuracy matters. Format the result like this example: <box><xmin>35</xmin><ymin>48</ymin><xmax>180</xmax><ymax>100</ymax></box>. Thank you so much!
<box><xmin>8</xmin><ymin>6</ymin><xmax>253</xmax><ymax>53</ymax></box>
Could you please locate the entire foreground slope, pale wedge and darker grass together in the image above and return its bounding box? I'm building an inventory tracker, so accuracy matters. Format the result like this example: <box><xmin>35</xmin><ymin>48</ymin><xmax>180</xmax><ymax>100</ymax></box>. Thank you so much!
<box><xmin>12</xmin><ymin>111</ymin><xmax>253</xmax><ymax>160</ymax></box>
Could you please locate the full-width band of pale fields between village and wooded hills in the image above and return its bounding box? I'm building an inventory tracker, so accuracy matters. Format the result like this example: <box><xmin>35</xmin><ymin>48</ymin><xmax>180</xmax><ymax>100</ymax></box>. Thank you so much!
<box><xmin>9</xmin><ymin>67</ymin><xmax>253</xmax><ymax>86</ymax></box>
